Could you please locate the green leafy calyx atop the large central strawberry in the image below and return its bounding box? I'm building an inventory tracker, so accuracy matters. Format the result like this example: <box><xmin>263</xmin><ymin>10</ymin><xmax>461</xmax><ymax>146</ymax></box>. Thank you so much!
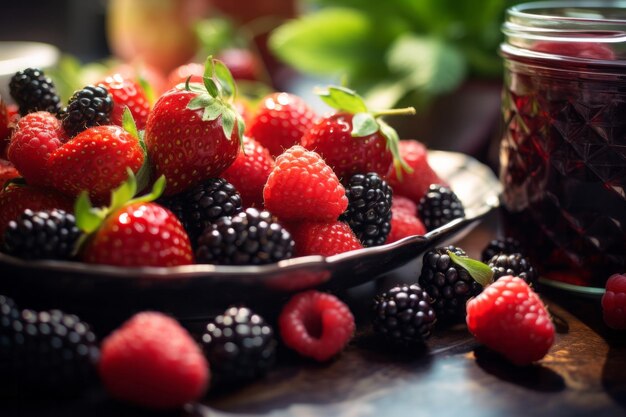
<box><xmin>184</xmin><ymin>55</ymin><xmax>245</xmax><ymax>143</ymax></box>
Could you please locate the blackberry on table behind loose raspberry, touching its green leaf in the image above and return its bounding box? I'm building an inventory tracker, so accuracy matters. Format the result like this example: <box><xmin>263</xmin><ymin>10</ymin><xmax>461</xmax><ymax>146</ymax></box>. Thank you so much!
<box><xmin>419</xmin><ymin>246</ymin><xmax>482</xmax><ymax>321</ymax></box>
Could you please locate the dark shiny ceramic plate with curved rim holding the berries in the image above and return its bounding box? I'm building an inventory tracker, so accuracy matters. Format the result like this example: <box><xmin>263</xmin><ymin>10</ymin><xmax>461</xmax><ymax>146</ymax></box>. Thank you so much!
<box><xmin>0</xmin><ymin>151</ymin><xmax>500</xmax><ymax>321</ymax></box>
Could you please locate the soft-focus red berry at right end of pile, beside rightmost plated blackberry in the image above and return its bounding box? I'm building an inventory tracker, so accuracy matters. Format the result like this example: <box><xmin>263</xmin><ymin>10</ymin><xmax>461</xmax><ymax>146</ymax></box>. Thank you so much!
<box><xmin>388</xmin><ymin>140</ymin><xmax>446</xmax><ymax>204</ymax></box>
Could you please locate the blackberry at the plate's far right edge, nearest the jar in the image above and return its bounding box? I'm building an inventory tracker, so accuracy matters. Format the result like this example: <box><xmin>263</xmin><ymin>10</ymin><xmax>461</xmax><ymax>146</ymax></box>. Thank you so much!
<box><xmin>417</xmin><ymin>184</ymin><xmax>465</xmax><ymax>231</ymax></box>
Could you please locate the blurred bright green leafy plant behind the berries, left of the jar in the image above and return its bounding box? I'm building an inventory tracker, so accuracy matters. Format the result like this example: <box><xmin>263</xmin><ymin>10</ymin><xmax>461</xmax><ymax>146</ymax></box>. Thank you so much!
<box><xmin>269</xmin><ymin>0</ymin><xmax>515</xmax><ymax>107</ymax></box>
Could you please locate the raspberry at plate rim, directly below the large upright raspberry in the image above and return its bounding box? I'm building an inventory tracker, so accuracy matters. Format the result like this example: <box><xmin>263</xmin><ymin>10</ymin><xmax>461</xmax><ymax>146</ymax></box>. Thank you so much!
<box><xmin>287</xmin><ymin>222</ymin><xmax>363</xmax><ymax>256</ymax></box>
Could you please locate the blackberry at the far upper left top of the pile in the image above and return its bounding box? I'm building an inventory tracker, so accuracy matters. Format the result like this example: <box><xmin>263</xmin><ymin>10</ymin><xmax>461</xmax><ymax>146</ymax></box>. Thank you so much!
<box><xmin>9</xmin><ymin>68</ymin><xmax>61</xmax><ymax>116</ymax></box>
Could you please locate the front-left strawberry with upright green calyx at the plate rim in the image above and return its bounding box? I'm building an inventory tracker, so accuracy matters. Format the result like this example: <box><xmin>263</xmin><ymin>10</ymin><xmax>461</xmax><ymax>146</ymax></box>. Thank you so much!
<box><xmin>74</xmin><ymin>170</ymin><xmax>193</xmax><ymax>267</ymax></box>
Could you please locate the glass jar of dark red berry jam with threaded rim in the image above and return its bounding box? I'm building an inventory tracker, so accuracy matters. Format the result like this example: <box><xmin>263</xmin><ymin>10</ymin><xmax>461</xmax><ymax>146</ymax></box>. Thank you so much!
<box><xmin>500</xmin><ymin>1</ymin><xmax>626</xmax><ymax>286</ymax></box>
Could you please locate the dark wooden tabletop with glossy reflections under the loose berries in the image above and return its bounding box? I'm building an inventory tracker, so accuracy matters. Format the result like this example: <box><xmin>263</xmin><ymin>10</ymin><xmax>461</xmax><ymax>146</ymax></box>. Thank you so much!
<box><xmin>0</xmin><ymin>213</ymin><xmax>626</xmax><ymax>417</ymax></box>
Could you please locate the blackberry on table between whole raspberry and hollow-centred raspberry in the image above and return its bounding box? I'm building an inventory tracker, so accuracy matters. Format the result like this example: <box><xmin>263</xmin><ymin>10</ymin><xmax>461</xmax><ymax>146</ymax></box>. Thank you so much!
<box><xmin>201</xmin><ymin>307</ymin><xmax>276</xmax><ymax>385</ymax></box>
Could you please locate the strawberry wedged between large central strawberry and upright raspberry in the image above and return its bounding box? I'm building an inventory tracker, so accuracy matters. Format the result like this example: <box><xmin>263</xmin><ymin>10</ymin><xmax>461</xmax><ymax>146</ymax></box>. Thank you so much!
<box><xmin>222</xmin><ymin>136</ymin><xmax>274</xmax><ymax>207</ymax></box>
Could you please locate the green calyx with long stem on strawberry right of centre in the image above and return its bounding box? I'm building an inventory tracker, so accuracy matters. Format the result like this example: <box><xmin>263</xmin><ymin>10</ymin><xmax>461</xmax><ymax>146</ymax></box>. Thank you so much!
<box><xmin>315</xmin><ymin>86</ymin><xmax>416</xmax><ymax>179</ymax></box>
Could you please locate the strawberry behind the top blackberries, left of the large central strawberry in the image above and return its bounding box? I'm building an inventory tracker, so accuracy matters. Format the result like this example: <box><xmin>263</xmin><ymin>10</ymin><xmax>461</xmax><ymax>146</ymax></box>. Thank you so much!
<box><xmin>96</xmin><ymin>74</ymin><xmax>150</xmax><ymax>130</ymax></box>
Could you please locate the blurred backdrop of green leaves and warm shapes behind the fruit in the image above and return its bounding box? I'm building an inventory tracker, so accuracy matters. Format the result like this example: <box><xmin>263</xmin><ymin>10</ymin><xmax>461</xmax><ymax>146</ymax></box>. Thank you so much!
<box><xmin>0</xmin><ymin>0</ymin><xmax>515</xmax><ymax>162</ymax></box>
